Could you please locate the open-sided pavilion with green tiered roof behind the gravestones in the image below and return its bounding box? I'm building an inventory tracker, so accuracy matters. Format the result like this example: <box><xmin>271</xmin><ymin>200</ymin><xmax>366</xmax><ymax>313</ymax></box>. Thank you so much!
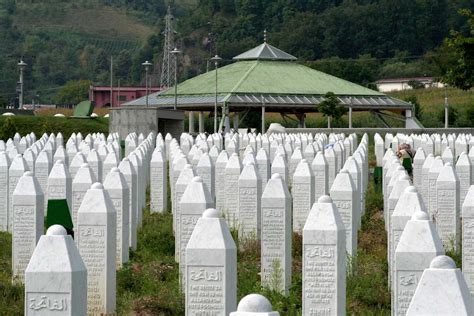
<box><xmin>125</xmin><ymin>42</ymin><xmax>416</xmax><ymax>132</ymax></box>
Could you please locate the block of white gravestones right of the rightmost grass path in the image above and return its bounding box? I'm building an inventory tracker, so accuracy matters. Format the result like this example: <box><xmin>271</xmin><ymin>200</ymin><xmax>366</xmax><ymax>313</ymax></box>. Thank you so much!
<box><xmin>374</xmin><ymin>134</ymin><xmax>474</xmax><ymax>315</ymax></box>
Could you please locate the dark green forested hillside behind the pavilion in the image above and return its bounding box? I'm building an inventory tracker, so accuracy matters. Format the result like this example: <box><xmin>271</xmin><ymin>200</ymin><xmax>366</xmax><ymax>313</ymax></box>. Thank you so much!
<box><xmin>0</xmin><ymin>0</ymin><xmax>474</xmax><ymax>104</ymax></box>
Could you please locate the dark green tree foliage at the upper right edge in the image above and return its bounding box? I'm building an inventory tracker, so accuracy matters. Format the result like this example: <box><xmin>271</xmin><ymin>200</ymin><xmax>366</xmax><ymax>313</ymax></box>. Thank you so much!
<box><xmin>443</xmin><ymin>9</ymin><xmax>474</xmax><ymax>90</ymax></box>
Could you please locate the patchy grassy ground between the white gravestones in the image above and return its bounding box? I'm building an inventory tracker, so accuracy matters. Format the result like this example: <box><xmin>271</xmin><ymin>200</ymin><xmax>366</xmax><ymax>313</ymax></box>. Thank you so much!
<box><xmin>0</xmin><ymin>149</ymin><xmax>390</xmax><ymax>316</ymax></box>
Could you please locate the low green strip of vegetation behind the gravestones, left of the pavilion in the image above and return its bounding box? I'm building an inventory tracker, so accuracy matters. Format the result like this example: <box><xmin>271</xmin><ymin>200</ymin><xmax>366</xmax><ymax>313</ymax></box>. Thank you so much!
<box><xmin>0</xmin><ymin>116</ymin><xmax>109</xmax><ymax>140</ymax></box>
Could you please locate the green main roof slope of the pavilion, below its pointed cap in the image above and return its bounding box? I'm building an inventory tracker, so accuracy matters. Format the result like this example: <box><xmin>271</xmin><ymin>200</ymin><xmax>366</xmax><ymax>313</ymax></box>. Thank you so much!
<box><xmin>157</xmin><ymin>60</ymin><xmax>384</xmax><ymax>97</ymax></box>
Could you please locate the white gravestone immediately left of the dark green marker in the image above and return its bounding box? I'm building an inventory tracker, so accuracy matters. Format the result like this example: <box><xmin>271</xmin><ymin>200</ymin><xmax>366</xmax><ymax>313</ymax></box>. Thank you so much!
<box><xmin>12</xmin><ymin>171</ymin><xmax>44</xmax><ymax>283</ymax></box>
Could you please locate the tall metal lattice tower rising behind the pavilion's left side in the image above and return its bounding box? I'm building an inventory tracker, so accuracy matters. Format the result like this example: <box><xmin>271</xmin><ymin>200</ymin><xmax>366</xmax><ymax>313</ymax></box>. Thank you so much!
<box><xmin>160</xmin><ymin>6</ymin><xmax>175</xmax><ymax>88</ymax></box>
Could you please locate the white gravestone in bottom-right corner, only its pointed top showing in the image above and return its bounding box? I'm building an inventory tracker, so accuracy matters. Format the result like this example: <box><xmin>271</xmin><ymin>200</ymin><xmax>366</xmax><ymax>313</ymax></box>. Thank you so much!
<box><xmin>406</xmin><ymin>256</ymin><xmax>474</xmax><ymax>316</ymax></box>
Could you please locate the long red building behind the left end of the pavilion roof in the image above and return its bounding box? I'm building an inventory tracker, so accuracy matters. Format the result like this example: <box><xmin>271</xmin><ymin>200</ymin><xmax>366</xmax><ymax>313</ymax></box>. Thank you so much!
<box><xmin>89</xmin><ymin>86</ymin><xmax>161</xmax><ymax>108</ymax></box>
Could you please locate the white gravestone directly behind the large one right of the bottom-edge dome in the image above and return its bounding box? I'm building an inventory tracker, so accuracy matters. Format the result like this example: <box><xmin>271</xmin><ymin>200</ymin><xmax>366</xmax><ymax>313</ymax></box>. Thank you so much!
<box><xmin>330</xmin><ymin>169</ymin><xmax>360</xmax><ymax>256</ymax></box>
